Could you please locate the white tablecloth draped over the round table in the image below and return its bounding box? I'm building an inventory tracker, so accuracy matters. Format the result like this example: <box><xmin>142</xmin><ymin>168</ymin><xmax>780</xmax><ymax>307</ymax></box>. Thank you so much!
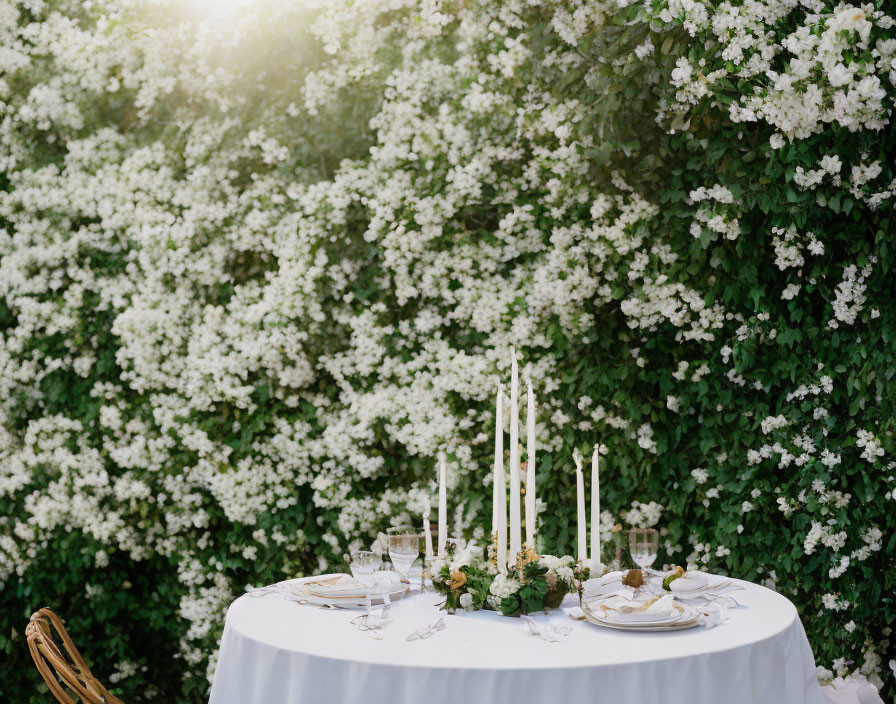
<box><xmin>210</xmin><ymin>582</ymin><xmax>828</xmax><ymax>704</ymax></box>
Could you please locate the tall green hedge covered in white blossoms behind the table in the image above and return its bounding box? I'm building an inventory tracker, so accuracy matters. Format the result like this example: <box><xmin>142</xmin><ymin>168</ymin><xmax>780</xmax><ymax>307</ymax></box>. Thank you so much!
<box><xmin>0</xmin><ymin>0</ymin><xmax>896</xmax><ymax>701</ymax></box>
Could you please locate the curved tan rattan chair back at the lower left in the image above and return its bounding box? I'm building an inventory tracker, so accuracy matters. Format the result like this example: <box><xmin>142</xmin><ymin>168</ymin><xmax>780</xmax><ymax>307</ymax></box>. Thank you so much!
<box><xmin>25</xmin><ymin>609</ymin><xmax>123</xmax><ymax>704</ymax></box>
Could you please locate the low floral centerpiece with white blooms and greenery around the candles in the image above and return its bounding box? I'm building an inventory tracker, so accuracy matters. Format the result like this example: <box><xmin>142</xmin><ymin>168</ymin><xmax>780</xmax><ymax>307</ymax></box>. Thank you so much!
<box><xmin>431</xmin><ymin>543</ymin><xmax>589</xmax><ymax>616</ymax></box>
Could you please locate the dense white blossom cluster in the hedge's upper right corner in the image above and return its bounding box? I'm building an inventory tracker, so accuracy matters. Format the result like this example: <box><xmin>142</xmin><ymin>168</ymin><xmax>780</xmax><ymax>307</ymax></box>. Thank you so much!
<box><xmin>659</xmin><ymin>0</ymin><xmax>896</xmax><ymax>140</ymax></box>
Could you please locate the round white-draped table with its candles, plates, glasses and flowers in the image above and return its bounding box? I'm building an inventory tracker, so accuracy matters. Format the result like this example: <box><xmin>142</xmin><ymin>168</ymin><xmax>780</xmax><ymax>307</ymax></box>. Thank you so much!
<box><xmin>210</xmin><ymin>355</ymin><xmax>856</xmax><ymax>704</ymax></box>
